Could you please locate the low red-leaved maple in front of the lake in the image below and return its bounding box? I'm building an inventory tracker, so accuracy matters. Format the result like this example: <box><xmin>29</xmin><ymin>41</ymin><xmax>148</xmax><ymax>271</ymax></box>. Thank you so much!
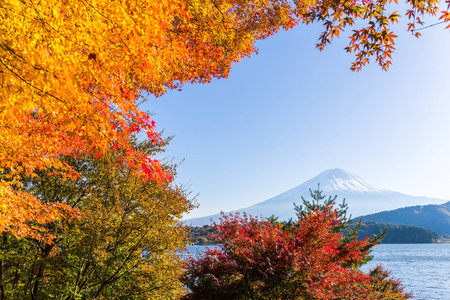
<box><xmin>182</xmin><ymin>192</ymin><xmax>411</xmax><ymax>299</ymax></box>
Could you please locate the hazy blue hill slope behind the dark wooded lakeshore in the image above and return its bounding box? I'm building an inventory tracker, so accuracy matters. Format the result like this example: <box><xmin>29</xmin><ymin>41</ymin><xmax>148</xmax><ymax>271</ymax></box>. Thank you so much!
<box><xmin>357</xmin><ymin>201</ymin><xmax>450</xmax><ymax>235</ymax></box>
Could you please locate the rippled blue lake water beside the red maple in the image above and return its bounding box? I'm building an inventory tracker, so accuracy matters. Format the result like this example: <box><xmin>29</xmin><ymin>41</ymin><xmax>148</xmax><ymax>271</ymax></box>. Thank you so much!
<box><xmin>189</xmin><ymin>244</ymin><xmax>450</xmax><ymax>300</ymax></box>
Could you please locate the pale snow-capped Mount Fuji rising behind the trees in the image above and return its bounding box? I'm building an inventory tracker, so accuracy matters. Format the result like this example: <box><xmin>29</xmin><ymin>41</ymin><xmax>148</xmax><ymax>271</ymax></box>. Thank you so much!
<box><xmin>185</xmin><ymin>169</ymin><xmax>448</xmax><ymax>226</ymax></box>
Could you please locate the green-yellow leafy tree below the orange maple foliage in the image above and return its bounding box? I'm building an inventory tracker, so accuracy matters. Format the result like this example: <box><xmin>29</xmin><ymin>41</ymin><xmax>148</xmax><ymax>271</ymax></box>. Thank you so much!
<box><xmin>0</xmin><ymin>142</ymin><xmax>194</xmax><ymax>300</ymax></box>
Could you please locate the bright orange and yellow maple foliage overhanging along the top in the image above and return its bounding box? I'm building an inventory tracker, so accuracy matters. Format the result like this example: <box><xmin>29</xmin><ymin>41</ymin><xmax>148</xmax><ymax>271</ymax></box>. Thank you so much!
<box><xmin>0</xmin><ymin>0</ymin><xmax>450</xmax><ymax>240</ymax></box>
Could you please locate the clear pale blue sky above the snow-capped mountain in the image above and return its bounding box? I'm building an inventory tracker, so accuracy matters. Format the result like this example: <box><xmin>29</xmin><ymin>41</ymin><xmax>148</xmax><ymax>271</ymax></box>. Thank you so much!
<box><xmin>143</xmin><ymin>15</ymin><xmax>450</xmax><ymax>217</ymax></box>
